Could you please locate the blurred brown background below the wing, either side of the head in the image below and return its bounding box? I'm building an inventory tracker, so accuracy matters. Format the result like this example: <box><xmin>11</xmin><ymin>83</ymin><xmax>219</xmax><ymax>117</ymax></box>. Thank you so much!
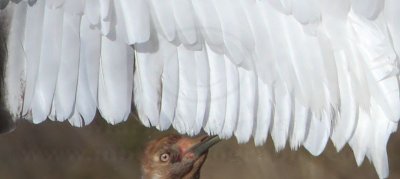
<box><xmin>0</xmin><ymin>115</ymin><xmax>400</xmax><ymax>179</ymax></box>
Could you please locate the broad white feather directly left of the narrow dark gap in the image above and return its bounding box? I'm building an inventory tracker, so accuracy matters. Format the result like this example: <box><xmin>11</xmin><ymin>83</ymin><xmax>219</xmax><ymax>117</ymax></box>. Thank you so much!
<box><xmin>98</xmin><ymin>37</ymin><xmax>134</xmax><ymax>124</ymax></box>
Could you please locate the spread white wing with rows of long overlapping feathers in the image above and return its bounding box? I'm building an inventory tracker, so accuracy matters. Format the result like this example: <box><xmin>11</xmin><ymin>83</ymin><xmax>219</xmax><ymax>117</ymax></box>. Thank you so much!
<box><xmin>0</xmin><ymin>0</ymin><xmax>400</xmax><ymax>178</ymax></box>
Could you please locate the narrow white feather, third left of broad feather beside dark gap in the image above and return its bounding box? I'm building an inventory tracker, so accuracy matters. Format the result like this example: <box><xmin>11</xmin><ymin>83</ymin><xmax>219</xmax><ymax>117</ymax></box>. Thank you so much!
<box><xmin>32</xmin><ymin>3</ymin><xmax>63</xmax><ymax>123</ymax></box>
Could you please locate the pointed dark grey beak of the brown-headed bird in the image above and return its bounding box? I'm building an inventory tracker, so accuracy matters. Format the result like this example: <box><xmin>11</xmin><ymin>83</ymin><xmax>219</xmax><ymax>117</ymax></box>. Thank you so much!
<box><xmin>187</xmin><ymin>136</ymin><xmax>221</xmax><ymax>157</ymax></box>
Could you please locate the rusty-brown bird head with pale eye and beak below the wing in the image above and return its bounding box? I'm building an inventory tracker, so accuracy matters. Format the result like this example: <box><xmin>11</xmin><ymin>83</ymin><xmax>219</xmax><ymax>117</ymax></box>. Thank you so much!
<box><xmin>142</xmin><ymin>135</ymin><xmax>219</xmax><ymax>179</ymax></box>
